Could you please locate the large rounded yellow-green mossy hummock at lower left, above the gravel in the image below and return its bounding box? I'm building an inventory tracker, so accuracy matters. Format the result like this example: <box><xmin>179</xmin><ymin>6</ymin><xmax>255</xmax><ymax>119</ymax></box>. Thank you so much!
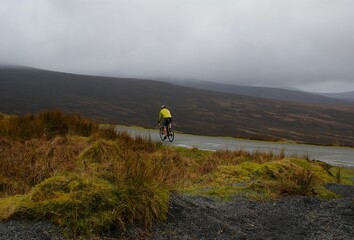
<box><xmin>20</xmin><ymin>175</ymin><xmax>126</xmax><ymax>235</ymax></box>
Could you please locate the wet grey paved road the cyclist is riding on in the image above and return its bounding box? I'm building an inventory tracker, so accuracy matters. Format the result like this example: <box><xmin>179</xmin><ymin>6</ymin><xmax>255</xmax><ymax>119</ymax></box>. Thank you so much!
<box><xmin>117</xmin><ymin>126</ymin><xmax>354</xmax><ymax>167</ymax></box>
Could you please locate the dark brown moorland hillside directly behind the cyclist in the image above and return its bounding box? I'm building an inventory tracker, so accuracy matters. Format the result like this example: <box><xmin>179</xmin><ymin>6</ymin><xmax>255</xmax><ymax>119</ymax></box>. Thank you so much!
<box><xmin>0</xmin><ymin>67</ymin><xmax>354</xmax><ymax>146</ymax></box>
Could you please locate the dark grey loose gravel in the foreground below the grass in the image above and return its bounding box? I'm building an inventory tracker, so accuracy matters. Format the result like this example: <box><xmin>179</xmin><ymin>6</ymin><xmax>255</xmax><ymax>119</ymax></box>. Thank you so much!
<box><xmin>0</xmin><ymin>184</ymin><xmax>354</xmax><ymax>240</ymax></box>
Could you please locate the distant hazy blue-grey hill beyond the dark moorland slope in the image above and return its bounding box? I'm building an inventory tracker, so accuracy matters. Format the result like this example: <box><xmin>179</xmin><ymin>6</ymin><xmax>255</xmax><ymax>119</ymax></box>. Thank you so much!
<box><xmin>174</xmin><ymin>80</ymin><xmax>353</xmax><ymax>105</ymax></box>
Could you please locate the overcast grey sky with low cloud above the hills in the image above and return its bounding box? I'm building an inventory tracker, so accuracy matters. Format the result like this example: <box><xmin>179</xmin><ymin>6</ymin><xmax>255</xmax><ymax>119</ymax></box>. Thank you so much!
<box><xmin>0</xmin><ymin>0</ymin><xmax>354</xmax><ymax>92</ymax></box>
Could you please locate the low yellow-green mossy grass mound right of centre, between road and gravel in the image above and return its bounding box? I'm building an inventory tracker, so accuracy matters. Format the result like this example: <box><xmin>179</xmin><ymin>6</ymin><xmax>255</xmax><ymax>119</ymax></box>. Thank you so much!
<box><xmin>188</xmin><ymin>158</ymin><xmax>336</xmax><ymax>199</ymax></box>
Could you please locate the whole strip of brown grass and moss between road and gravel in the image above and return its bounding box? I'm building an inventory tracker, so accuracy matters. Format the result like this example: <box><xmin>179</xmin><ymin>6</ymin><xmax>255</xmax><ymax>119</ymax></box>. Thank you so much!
<box><xmin>0</xmin><ymin>111</ymin><xmax>354</xmax><ymax>238</ymax></box>
